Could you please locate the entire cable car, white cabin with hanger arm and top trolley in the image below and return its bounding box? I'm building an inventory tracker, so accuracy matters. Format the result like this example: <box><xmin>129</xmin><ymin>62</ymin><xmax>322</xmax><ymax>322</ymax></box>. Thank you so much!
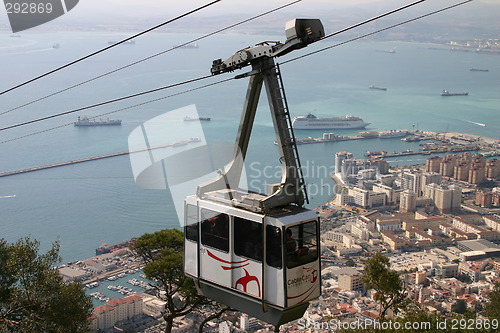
<box><xmin>184</xmin><ymin>19</ymin><xmax>325</xmax><ymax>328</ymax></box>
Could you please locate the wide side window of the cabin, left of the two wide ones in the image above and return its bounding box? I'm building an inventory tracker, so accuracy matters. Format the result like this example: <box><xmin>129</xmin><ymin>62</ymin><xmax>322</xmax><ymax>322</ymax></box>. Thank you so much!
<box><xmin>201</xmin><ymin>209</ymin><xmax>229</xmax><ymax>252</ymax></box>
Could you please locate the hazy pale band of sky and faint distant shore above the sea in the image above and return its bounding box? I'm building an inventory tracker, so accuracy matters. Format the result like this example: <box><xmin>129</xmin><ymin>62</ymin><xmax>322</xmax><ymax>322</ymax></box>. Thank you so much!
<box><xmin>0</xmin><ymin>0</ymin><xmax>500</xmax><ymax>38</ymax></box>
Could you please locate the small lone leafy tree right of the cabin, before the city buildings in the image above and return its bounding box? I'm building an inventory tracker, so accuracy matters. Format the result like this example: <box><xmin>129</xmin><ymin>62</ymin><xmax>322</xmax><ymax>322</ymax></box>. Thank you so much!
<box><xmin>361</xmin><ymin>252</ymin><xmax>407</xmax><ymax>318</ymax></box>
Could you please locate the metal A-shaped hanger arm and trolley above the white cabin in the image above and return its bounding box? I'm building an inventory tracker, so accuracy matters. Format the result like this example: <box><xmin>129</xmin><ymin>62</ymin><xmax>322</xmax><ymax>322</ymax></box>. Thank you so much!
<box><xmin>197</xmin><ymin>19</ymin><xmax>324</xmax><ymax>213</ymax></box>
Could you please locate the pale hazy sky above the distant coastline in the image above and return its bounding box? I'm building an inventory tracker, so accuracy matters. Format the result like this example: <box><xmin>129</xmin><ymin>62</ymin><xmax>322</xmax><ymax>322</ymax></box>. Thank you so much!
<box><xmin>0</xmin><ymin>0</ymin><xmax>500</xmax><ymax>32</ymax></box>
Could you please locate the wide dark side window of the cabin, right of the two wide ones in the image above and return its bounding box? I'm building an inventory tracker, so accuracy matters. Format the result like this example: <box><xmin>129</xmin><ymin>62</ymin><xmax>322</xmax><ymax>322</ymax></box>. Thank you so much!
<box><xmin>234</xmin><ymin>216</ymin><xmax>263</xmax><ymax>261</ymax></box>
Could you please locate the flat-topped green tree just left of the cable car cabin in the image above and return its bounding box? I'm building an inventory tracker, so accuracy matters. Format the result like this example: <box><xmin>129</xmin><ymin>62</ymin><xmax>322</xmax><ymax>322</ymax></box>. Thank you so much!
<box><xmin>132</xmin><ymin>229</ymin><xmax>209</xmax><ymax>333</ymax></box>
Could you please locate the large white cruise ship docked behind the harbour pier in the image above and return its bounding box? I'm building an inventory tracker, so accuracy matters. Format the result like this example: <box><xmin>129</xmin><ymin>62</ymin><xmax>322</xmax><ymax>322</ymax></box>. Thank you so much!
<box><xmin>292</xmin><ymin>113</ymin><xmax>370</xmax><ymax>130</ymax></box>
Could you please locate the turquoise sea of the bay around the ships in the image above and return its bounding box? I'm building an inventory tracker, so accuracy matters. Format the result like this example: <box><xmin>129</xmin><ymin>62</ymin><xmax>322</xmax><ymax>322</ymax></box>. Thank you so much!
<box><xmin>0</xmin><ymin>32</ymin><xmax>500</xmax><ymax>261</ymax></box>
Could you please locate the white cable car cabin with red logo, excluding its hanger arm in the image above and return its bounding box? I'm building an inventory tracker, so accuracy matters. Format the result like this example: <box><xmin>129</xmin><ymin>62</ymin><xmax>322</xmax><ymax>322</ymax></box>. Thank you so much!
<box><xmin>184</xmin><ymin>196</ymin><xmax>321</xmax><ymax>326</ymax></box>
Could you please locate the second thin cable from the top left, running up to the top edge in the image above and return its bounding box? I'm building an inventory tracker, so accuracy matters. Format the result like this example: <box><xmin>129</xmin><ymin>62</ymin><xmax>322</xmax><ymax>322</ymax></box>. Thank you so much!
<box><xmin>0</xmin><ymin>0</ymin><xmax>303</xmax><ymax>116</ymax></box>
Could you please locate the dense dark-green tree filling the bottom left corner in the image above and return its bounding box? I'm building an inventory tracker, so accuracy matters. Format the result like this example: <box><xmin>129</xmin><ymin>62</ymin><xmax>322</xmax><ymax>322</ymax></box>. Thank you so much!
<box><xmin>0</xmin><ymin>238</ymin><xmax>92</xmax><ymax>333</ymax></box>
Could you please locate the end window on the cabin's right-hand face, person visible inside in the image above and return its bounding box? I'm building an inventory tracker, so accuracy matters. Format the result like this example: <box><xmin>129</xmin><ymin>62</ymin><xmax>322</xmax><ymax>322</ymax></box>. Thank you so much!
<box><xmin>285</xmin><ymin>221</ymin><xmax>318</xmax><ymax>268</ymax></box>
